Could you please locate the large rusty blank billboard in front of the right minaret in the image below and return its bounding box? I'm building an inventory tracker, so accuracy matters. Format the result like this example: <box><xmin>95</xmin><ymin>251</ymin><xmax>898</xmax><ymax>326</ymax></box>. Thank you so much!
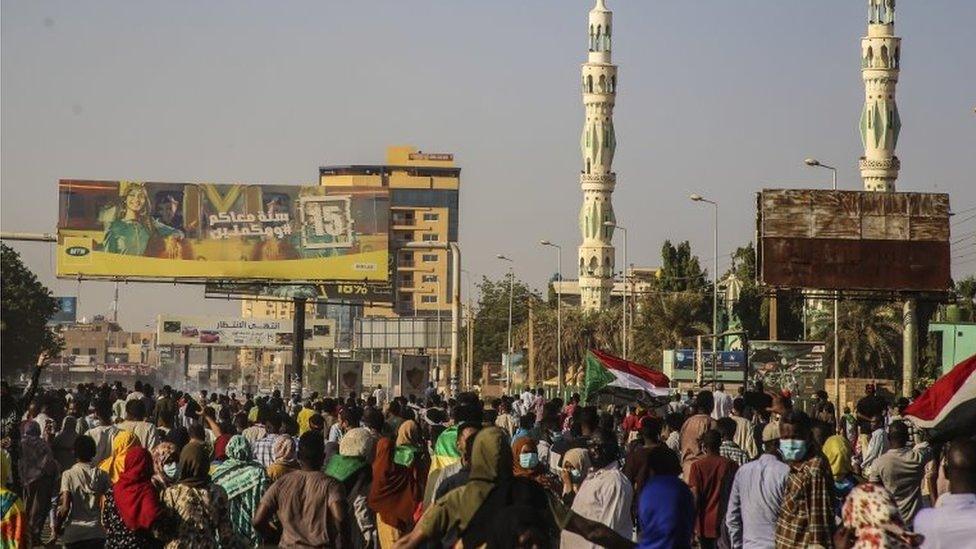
<box><xmin>757</xmin><ymin>189</ymin><xmax>951</xmax><ymax>292</ymax></box>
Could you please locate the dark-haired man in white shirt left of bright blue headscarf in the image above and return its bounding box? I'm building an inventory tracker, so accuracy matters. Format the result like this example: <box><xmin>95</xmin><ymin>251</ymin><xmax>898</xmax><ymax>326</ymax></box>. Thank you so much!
<box><xmin>559</xmin><ymin>429</ymin><xmax>634</xmax><ymax>549</ymax></box>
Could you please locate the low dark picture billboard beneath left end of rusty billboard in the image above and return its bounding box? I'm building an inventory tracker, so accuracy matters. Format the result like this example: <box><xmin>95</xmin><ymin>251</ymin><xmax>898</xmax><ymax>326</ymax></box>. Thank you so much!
<box><xmin>749</xmin><ymin>341</ymin><xmax>826</xmax><ymax>412</ymax></box>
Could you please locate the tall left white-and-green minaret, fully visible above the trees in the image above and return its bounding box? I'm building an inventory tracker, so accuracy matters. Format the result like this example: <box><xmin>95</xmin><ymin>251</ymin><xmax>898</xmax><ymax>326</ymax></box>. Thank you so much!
<box><xmin>579</xmin><ymin>0</ymin><xmax>617</xmax><ymax>311</ymax></box>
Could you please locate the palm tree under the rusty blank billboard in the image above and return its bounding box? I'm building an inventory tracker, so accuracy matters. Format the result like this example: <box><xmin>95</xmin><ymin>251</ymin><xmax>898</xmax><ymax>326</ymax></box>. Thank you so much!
<box><xmin>811</xmin><ymin>301</ymin><xmax>902</xmax><ymax>378</ymax></box>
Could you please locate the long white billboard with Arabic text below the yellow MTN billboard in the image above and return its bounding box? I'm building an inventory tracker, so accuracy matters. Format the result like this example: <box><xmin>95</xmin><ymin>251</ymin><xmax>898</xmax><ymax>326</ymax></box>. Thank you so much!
<box><xmin>156</xmin><ymin>315</ymin><xmax>335</xmax><ymax>350</ymax></box>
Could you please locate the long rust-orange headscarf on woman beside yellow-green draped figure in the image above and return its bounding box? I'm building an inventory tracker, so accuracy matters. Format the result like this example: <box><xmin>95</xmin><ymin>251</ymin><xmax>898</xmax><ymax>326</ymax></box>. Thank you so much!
<box><xmin>368</xmin><ymin>421</ymin><xmax>428</xmax><ymax>531</ymax></box>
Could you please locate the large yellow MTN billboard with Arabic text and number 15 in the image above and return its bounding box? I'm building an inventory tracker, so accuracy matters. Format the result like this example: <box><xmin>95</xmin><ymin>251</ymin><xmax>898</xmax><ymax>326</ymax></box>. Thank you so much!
<box><xmin>57</xmin><ymin>180</ymin><xmax>390</xmax><ymax>282</ymax></box>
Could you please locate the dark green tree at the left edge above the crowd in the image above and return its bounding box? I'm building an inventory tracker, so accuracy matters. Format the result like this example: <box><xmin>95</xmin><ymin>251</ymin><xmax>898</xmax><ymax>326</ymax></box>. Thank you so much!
<box><xmin>0</xmin><ymin>244</ymin><xmax>61</xmax><ymax>372</ymax></box>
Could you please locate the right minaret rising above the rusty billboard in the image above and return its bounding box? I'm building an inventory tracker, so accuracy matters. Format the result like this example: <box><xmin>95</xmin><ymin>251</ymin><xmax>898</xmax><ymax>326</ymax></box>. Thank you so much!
<box><xmin>860</xmin><ymin>0</ymin><xmax>901</xmax><ymax>192</ymax></box>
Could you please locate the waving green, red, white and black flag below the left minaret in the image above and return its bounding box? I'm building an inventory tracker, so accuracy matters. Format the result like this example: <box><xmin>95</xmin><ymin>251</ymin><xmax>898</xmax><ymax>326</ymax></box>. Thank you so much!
<box><xmin>583</xmin><ymin>350</ymin><xmax>671</xmax><ymax>401</ymax></box>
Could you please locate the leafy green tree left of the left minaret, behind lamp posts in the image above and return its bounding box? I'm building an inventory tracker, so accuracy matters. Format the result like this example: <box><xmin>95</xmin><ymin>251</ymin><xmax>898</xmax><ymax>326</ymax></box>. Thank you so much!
<box><xmin>474</xmin><ymin>276</ymin><xmax>539</xmax><ymax>377</ymax></box>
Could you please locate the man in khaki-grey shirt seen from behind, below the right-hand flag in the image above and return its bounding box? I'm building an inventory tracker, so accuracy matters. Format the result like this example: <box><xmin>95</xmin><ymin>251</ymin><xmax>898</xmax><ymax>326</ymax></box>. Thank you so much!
<box><xmin>868</xmin><ymin>421</ymin><xmax>932</xmax><ymax>526</ymax></box>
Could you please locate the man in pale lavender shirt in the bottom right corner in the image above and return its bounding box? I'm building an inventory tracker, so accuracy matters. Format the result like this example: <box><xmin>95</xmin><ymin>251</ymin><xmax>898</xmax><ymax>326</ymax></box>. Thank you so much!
<box><xmin>915</xmin><ymin>438</ymin><xmax>976</xmax><ymax>549</ymax></box>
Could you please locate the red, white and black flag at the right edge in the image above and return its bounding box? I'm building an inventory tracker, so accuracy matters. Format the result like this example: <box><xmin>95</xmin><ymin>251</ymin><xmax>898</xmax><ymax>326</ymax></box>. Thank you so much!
<box><xmin>905</xmin><ymin>355</ymin><xmax>976</xmax><ymax>440</ymax></box>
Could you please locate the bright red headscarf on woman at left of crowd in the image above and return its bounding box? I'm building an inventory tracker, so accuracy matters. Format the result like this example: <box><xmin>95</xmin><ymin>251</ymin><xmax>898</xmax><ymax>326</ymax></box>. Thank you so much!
<box><xmin>112</xmin><ymin>446</ymin><xmax>160</xmax><ymax>531</ymax></box>
